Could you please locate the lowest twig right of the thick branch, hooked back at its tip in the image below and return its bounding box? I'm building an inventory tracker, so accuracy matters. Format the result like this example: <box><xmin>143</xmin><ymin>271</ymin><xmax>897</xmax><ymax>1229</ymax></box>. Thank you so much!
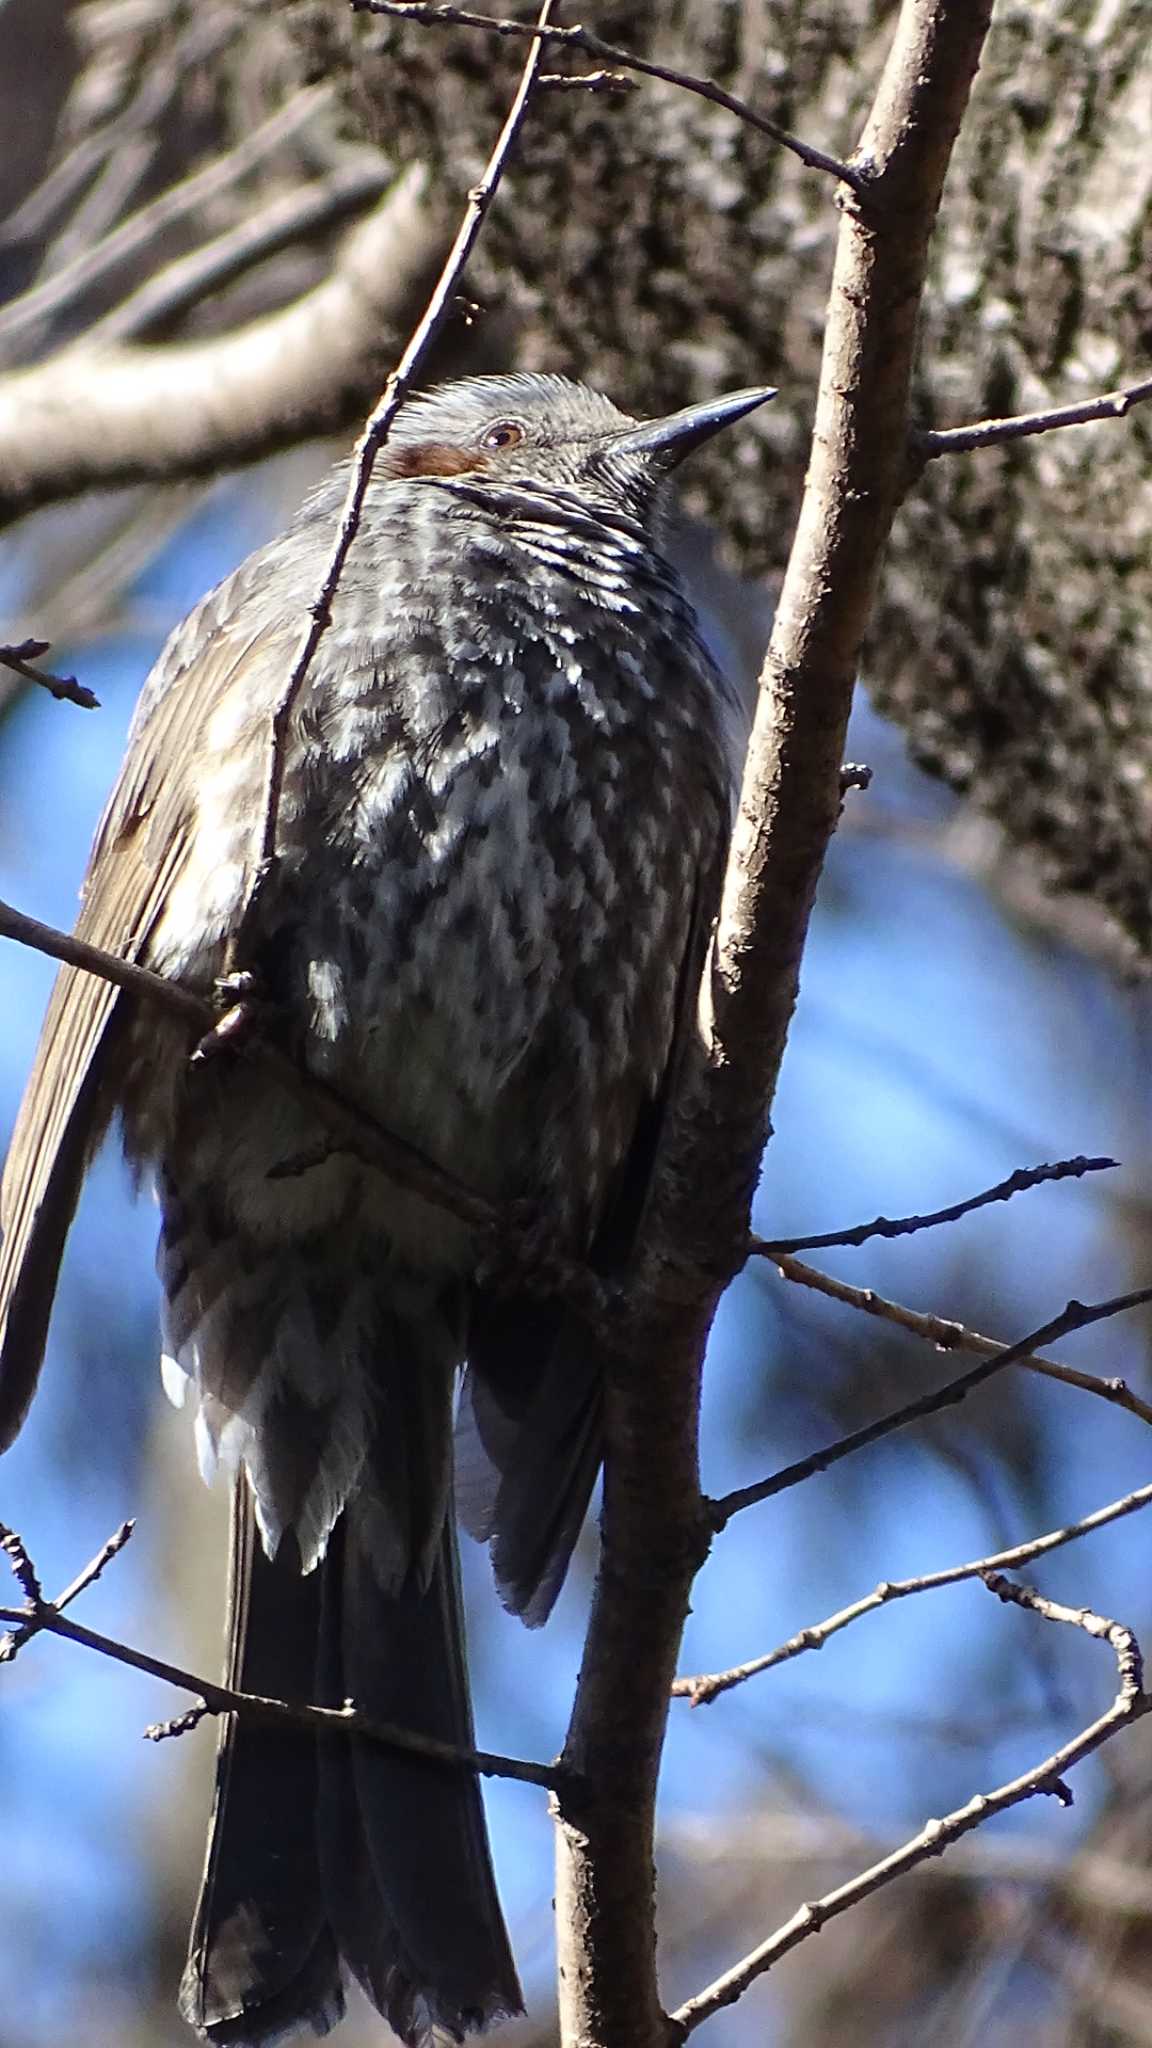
<box><xmin>670</xmin><ymin>1581</ymin><xmax>1152</xmax><ymax>2042</ymax></box>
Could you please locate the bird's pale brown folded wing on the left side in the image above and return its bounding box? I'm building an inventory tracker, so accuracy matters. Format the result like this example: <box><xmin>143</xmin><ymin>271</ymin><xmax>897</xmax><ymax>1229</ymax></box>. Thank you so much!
<box><xmin>0</xmin><ymin>557</ymin><xmax>291</xmax><ymax>1450</ymax></box>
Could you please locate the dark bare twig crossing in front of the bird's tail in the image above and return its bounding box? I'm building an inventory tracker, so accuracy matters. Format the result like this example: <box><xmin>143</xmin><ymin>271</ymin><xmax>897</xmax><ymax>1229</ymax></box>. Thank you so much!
<box><xmin>0</xmin><ymin>1526</ymin><xmax>566</xmax><ymax>1792</ymax></box>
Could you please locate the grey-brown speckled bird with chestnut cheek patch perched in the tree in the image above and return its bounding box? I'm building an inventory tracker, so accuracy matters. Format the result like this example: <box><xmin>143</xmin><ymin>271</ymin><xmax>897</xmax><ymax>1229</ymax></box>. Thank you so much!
<box><xmin>0</xmin><ymin>375</ymin><xmax>771</xmax><ymax>2048</ymax></box>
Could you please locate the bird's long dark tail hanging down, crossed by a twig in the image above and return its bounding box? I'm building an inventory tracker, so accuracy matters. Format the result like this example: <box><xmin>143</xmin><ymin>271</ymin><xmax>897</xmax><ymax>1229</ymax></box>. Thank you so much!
<box><xmin>180</xmin><ymin>1481</ymin><xmax>521</xmax><ymax>2048</ymax></box>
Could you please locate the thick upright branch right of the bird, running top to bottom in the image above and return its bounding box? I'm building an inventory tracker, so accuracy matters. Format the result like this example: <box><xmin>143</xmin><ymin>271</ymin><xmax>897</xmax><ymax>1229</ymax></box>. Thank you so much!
<box><xmin>545</xmin><ymin>0</ymin><xmax>990</xmax><ymax>2048</ymax></box>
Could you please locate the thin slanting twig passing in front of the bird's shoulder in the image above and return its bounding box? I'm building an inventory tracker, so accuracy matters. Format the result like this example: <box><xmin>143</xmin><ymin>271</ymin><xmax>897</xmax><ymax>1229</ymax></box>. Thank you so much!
<box><xmin>249</xmin><ymin>0</ymin><xmax>553</xmax><ymax>884</ymax></box>
